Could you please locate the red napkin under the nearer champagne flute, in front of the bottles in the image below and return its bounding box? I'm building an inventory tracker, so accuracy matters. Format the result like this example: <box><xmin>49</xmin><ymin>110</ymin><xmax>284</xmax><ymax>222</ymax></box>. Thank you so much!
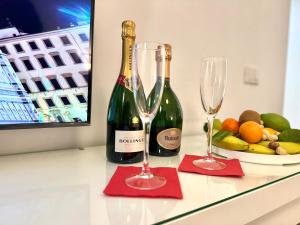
<box><xmin>103</xmin><ymin>166</ymin><xmax>183</xmax><ymax>199</ymax></box>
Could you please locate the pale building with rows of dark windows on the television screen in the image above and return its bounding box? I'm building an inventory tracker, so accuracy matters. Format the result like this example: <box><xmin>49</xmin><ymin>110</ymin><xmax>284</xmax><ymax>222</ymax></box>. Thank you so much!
<box><xmin>0</xmin><ymin>25</ymin><xmax>90</xmax><ymax>122</ymax></box>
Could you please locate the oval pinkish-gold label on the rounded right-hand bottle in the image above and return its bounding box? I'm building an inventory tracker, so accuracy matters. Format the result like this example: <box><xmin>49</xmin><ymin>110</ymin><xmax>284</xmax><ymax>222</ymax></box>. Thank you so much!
<box><xmin>156</xmin><ymin>128</ymin><xmax>181</xmax><ymax>150</ymax></box>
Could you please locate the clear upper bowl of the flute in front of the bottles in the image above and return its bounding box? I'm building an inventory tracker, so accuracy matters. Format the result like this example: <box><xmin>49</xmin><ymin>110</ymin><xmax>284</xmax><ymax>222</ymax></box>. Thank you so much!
<box><xmin>132</xmin><ymin>42</ymin><xmax>165</xmax><ymax>120</ymax></box>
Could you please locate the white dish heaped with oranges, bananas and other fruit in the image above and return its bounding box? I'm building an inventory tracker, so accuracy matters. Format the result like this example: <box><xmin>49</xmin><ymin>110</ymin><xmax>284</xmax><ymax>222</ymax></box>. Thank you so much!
<box><xmin>210</xmin><ymin>110</ymin><xmax>300</xmax><ymax>165</ymax></box>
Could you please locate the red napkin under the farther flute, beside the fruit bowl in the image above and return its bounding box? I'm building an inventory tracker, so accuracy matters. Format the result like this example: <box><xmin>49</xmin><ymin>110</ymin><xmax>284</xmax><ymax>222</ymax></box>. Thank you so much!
<box><xmin>178</xmin><ymin>155</ymin><xmax>245</xmax><ymax>177</ymax></box>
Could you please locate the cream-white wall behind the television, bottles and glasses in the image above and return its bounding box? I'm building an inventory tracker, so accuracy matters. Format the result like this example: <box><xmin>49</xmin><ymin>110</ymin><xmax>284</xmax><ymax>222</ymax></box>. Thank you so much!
<box><xmin>0</xmin><ymin>0</ymin><xmax>289</xmax><ymax>154</ymax></box>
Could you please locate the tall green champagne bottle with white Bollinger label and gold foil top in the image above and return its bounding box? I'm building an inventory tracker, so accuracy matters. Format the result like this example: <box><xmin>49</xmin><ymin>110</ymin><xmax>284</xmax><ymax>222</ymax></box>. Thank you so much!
<box><xmin>106</xmin><ymin>20</ymin><xmax>145</xmax><ymax>163</ymax></box>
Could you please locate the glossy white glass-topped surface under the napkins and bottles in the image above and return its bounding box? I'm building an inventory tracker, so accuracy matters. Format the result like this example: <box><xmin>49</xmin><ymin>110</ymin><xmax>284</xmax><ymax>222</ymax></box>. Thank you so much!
<box><xmin>0</xmin><ymin>136</ymin><xmax>300</xmax><ymax>225</ymax></box>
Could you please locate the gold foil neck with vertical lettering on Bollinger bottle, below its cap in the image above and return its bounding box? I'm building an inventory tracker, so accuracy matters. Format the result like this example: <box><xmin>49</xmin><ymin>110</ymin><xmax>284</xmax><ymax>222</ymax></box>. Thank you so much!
<box><xmin>120</xmin><ymin>37</ymin><xmax>135</xmax><ymax>78</ymax></box>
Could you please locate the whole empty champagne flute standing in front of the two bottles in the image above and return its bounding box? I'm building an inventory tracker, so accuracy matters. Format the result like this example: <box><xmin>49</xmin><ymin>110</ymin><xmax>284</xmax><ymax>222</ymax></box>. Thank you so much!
<box><xmin>125</xmin><ymin>42</ymin><xmax>167</xmax><ymax>190</ymax></box>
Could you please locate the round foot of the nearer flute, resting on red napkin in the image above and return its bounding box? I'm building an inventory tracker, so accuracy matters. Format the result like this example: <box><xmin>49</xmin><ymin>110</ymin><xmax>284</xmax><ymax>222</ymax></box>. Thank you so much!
<box><xmin>125</xmin><ymin>174</ymin><xmax>167</xmax><ymax>190</ymax></box>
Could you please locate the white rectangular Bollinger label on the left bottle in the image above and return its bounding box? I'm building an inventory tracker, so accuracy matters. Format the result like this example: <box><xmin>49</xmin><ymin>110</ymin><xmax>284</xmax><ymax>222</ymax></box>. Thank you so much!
<box><xmin>115</xmin><ymin>130</ymin><xmax>145</xmax><ymax>152</ymax></box>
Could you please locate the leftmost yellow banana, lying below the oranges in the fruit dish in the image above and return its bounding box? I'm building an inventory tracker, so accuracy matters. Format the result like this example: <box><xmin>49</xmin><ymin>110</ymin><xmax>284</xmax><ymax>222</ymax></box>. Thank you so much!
<box><xmin>213</xmin><ymin>136</ymin><xmax>249</xmax><ymax>151</ymax></box>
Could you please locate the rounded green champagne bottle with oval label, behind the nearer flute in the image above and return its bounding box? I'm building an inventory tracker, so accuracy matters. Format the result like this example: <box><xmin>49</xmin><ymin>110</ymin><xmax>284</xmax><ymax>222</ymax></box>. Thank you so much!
<box><xmin>148</xmin><ymin>44</ymin><xmax>182</xmax><ymax>156</ymax></box>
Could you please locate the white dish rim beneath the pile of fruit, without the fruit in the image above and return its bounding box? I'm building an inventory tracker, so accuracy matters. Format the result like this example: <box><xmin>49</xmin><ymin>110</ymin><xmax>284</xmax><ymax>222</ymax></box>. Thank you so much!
<box><xmin>213</xmin><ymin>146</ymin><xmax>300</xmax><ymax>165</ymax></box>
